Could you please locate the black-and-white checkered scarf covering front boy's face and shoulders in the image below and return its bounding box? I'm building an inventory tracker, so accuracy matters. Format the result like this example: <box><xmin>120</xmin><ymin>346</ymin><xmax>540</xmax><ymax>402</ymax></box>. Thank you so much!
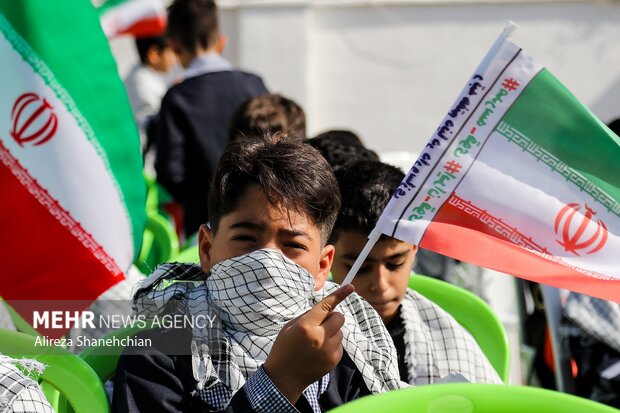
<box><xmin>134</xmin><ymin>249</ymin><xmax>404</xmax><ymax>408</ymax></box>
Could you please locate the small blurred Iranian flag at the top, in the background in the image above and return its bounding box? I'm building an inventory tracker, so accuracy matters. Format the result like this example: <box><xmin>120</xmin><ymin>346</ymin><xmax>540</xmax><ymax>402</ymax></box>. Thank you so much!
<box><xmin>97</xmin><ymin>0</ymin><xmax>168</xmax><ymax>37</ymax></box>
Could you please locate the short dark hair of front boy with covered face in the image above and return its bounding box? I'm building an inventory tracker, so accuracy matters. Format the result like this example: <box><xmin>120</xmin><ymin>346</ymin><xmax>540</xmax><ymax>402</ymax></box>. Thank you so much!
<box><xmin>209</xmin><ymin>133</ymin><xmax>340</xmax><ymax>245</ymax></box>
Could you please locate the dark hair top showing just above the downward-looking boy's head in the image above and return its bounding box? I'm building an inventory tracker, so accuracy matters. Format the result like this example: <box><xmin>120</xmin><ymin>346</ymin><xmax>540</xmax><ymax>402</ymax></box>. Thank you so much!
<box><xmin>308</xmin><ymin>130</ymin><xmax>379</xmax><ymax>172</ymax></box>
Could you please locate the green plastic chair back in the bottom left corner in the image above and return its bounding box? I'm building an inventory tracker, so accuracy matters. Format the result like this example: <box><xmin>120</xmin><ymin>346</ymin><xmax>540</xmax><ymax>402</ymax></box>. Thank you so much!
<box><xmin>0</xmin><ymin>329</ymin><xmax>111</xmax><ymax>413</ymax></box>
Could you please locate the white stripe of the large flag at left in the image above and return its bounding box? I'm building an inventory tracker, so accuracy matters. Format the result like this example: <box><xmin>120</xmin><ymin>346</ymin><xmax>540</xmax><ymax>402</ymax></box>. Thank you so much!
<box><xmin>0</xmin><ymin>23</ymin><xmax>133</xmax><ymax>270</ymax></box>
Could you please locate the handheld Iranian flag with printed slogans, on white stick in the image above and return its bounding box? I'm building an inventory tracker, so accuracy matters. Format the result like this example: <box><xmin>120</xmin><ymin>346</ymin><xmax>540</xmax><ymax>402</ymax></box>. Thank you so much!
<box><xmin>344</xmin><ymin>27</ymin><xmax>620</xmax><ymax>302</ymax></box>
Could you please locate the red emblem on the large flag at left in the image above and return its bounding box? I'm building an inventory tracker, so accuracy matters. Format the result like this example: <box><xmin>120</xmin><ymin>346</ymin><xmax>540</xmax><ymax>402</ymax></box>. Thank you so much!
<box><xmin>11</xmin><ymin>93</ymin><xmax>58</xmax><ymax>146</ymax></box>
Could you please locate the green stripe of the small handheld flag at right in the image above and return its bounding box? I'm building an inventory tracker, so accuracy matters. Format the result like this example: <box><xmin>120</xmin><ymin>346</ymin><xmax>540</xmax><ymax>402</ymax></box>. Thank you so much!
<box><xmin>498</xmin><ymin>70</ymin><xmax>620</xmax><ymax>214</ymax></box>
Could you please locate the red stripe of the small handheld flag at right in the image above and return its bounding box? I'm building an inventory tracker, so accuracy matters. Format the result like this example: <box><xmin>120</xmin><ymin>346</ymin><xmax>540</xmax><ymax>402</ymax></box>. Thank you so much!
<box><xmin>420</xmin><ymin>196</ymin><xmax>620</xmax><ymax>303</ymax></box>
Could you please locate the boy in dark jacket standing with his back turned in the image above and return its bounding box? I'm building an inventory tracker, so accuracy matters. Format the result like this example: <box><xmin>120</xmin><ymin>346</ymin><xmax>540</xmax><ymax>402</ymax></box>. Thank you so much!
<box><xmin>154</xmin><ymin>0</ymin><xmax>267</xmax><ymax>237</ymax></box>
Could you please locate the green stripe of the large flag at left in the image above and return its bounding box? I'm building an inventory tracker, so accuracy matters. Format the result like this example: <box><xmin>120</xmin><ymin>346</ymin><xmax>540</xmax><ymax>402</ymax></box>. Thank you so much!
<box><xmin>0</xmin><ymin>0</ymin><xmax>146</xmax><ymax>256</ymax></box>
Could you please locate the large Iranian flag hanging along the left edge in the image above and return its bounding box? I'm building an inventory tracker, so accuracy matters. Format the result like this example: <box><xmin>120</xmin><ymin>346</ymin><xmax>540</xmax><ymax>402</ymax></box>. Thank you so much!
<box><xmin>0</xmin><ymin>0</ymin><xmax>145</xmax><ymax>328</ymax></box>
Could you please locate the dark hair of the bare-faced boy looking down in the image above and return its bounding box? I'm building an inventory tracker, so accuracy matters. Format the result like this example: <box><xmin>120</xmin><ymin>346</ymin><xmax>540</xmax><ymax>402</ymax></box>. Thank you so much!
<box><xmin>329</xmin><ymin>160</ymin><xmax>405</xmax><ymax>243</ymax></box>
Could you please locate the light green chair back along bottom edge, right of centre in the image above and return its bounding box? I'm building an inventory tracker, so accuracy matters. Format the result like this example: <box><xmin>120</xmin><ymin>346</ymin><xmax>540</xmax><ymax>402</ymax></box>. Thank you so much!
<box><xmin>330</xmin><ymin>383</ymin><xmax>619</xmax><ymax>413</ymax></box>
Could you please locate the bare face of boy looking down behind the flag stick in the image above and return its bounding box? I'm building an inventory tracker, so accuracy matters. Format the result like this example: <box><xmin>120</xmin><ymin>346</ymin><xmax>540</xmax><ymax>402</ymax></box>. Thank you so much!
<box><xmin>332</xmin><ymin>231</ymin><xmax>417</xmax><ymax>323</ymax></box>
